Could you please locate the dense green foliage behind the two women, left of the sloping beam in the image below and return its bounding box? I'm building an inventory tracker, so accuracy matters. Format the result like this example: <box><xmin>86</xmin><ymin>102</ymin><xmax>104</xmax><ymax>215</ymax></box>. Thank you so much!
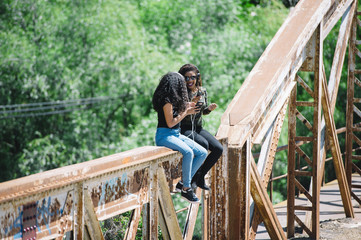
<box><xmin>0</xmin><ymin>0</ymin><xmax>287</xmax><ymax>181</ymax></box>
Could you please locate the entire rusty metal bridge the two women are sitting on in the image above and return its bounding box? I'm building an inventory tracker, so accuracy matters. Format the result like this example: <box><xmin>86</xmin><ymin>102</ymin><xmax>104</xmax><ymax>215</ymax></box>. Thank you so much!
<box><xmin>0</xmin><ymin>0</ymin><xmax>361</xmax><ymax>239</ymax></box>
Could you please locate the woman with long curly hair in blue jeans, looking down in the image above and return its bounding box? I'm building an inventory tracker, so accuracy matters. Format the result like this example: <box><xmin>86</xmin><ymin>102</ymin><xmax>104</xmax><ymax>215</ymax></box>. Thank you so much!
<box><xmin>152</xmin><ymin>72</ymin><xmax>207</xmax><ymax>203</ymax></box>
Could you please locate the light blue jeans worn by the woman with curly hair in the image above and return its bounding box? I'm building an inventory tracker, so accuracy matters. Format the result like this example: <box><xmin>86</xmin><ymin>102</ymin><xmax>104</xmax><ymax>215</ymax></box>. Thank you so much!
<box><xmin>155</xmin><ymin>128</ymin><xmax>208</xmax><ymax>187</ymax></box>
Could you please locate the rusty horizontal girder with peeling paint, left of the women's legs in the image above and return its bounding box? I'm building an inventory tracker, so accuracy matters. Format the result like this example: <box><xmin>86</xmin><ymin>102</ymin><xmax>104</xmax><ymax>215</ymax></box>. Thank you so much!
<box><xmin>0</xmin><ymin>147</ymin><xmax>182</xmax><ymax>239</ymax></box>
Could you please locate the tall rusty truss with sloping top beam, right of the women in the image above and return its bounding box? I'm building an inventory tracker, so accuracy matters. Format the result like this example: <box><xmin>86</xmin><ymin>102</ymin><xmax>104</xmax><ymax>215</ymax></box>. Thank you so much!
<box><xmin>217</xmin><ymin>1</ymin><xmax>361</xmax><ymax>239</ymax></box>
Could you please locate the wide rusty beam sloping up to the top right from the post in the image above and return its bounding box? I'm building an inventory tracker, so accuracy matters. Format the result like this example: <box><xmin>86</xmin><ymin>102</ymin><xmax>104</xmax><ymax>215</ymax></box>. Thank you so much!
<box><xmin>217</xmin><ymin>0</ymin><xmax>331</xmax><ymax>145</ymax></box>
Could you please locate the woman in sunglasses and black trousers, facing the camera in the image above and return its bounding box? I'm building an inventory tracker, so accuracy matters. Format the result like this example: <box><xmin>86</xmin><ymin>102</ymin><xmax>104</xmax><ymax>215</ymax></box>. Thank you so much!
<box><xmin>177</xmin><ymin>64</ymin><xmax>223</xmax><ymax>190</ymax></box>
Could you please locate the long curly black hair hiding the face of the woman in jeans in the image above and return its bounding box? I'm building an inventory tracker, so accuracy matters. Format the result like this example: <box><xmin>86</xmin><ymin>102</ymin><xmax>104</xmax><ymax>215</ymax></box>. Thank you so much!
<box><xmin>152</xmin><ymin>72</ymin><xmax>188</xmax><ymax>113</ymax></box>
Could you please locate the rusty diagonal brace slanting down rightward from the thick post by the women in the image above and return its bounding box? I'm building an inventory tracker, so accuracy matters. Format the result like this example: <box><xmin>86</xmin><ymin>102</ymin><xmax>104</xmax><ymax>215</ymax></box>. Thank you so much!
<box><xmin>249</xmin><ymin>159</ymin><xmax>287</xmax><ymax>240</ymax></box>
